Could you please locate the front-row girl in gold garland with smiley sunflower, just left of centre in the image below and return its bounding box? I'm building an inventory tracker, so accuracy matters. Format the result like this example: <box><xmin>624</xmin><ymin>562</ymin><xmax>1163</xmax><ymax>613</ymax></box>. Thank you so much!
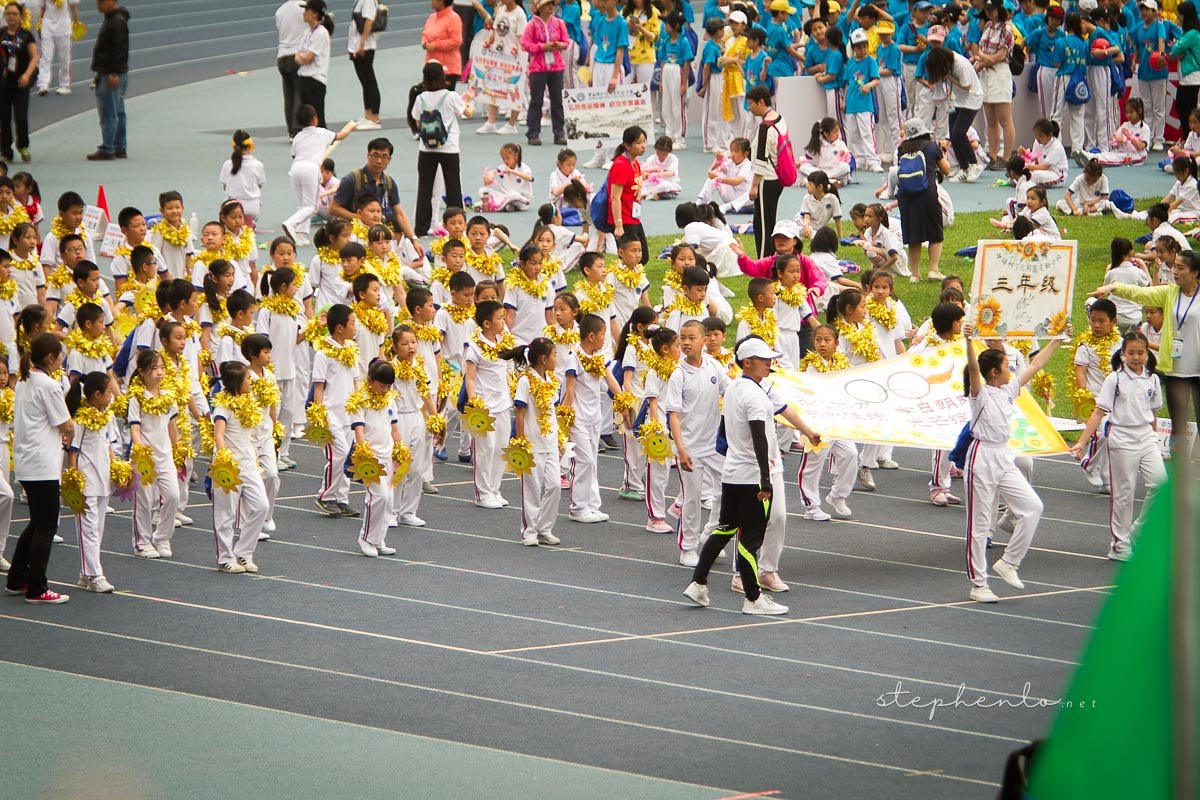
<box><xmin>505</xmin><ymin>336</ymin><xmax>563</xmax><ymax>547</ymax></box>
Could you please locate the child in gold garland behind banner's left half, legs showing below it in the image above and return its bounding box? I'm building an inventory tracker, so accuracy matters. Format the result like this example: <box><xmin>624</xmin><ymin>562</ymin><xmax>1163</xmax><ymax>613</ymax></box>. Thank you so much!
<box><xmin>796</xmin><ymin>325</ymin><xmax>858</xmax><ymax>522</ymax></box>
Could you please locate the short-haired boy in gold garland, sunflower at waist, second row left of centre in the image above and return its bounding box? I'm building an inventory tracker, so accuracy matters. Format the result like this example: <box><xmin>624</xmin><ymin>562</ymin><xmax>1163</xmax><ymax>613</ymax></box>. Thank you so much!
<box><xmin>458</xmin><ymin>300</ymin><xmax>516</xmax><ymax>509</ymax></box>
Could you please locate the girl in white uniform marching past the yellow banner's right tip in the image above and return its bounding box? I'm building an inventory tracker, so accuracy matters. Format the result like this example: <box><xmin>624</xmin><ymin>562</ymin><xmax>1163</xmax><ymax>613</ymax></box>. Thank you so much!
<box><xmin>1070</xmin><ymin>332</ymin><xmax>1166</xmax><ymax>561</ymax></box>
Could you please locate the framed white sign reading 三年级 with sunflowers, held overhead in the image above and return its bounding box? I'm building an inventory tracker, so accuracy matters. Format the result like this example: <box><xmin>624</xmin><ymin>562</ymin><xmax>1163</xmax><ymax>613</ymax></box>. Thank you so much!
<box><xmin>970</xmin><ymin>240</ymin><xmax>1078</xmax><ymax>338</ymax></box>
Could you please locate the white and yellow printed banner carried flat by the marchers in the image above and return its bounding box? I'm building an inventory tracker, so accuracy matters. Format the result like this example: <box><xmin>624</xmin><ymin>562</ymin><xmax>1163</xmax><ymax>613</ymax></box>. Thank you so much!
<box><xmin>767</xmin><ymin>342</ymin><xmax>1067</xmax><ymax>456</ymax></box>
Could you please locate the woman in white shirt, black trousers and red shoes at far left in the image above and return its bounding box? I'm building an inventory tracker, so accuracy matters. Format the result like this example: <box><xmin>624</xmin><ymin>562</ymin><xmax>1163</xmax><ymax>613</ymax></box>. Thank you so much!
<box><xmin>5</xmin><ymin>333</ymin><xmax>74</xmax><ymax>604</ymax></box>
